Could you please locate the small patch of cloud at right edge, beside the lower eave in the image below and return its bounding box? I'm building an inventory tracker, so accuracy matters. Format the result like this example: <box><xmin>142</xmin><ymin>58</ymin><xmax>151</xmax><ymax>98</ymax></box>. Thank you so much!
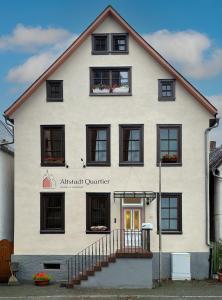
<box><xmin>208</xmin><ymin>94</ymin><xmax>222</xmax><ymax>146</ymax></box>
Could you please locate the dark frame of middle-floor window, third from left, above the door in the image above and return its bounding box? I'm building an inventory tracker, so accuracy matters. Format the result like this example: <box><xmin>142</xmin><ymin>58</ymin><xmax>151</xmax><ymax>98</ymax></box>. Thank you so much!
<box><xmin>119</xmin><ymin>124</ymin><xmax>144</xmax><ymax>166</ymax></box>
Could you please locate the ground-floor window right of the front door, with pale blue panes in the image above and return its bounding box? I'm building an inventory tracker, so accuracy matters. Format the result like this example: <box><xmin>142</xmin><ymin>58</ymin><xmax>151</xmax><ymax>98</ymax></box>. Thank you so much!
<box><xmin>157</xmin><ymin>193</ymin><xmax>182</xmax><ymax>233</ymax></box>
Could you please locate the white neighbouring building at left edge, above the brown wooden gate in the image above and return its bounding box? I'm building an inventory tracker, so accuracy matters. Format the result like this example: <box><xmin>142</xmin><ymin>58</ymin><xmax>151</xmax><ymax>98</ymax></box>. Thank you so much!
<box><xmin>0</xmin><ymin>120</ymin><xmax>14</xmax><ymax>241</ymax></box>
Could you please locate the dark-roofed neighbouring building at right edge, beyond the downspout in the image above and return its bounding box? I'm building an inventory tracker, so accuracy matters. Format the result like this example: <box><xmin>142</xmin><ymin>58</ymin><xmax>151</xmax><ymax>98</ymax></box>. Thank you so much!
<box><xmin>209</xmin><ymin>142</ymin><xmax>222</xmax><ymax>241</ymax></box>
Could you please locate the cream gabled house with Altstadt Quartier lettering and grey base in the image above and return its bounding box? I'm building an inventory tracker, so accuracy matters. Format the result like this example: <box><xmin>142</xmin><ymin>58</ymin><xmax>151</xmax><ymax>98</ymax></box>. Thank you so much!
<box><xmin>5</xmin><ymin>6</ymin><xmax>217</xmax><ymax>286</ymax></box>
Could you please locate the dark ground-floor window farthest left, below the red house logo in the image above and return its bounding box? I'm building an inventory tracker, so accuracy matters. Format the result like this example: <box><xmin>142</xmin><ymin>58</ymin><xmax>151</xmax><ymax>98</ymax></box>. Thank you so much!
<box><xmin>40</xmin><ymin>193</ymin><xmax>65</xmax><ymax>233</ymax></box>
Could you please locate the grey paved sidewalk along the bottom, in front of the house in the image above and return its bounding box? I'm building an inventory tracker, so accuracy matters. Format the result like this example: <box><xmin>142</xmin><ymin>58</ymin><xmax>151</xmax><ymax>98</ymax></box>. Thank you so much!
<box><xmin>0</xmin><ymin>280</ymin><xmax>222</xmax><ymax>300</ymax></box>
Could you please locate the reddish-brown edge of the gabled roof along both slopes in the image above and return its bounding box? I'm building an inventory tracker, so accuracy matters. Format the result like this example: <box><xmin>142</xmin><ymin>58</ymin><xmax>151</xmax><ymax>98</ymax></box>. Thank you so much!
<box><xmin>5</xmin><ymin>6</ymin><xmax>217</xmax><ymax>118</ymax></box>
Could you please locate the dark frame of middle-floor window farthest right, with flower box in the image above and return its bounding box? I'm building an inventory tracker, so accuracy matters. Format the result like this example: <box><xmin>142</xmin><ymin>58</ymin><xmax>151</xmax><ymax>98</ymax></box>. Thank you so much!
<box><xmin>156</xmin><ymin>124</ymin><xmax>182</xmax><ymax>167</ymax></box>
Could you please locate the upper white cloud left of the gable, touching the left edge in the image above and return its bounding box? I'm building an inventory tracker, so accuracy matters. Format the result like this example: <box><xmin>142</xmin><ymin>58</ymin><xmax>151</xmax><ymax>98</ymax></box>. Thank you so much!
<box><xmin>0</xmin><ymin>24</ymin><xmax>71</xmax><ymax>51</ymax></box>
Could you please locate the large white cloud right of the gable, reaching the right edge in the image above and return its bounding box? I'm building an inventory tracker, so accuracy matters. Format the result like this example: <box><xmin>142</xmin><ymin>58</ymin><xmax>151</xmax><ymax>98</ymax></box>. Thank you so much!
<box><xmin>143</xmin><ymin>29</ymin><xmax>222</xmax><ymax>79</ymax></box>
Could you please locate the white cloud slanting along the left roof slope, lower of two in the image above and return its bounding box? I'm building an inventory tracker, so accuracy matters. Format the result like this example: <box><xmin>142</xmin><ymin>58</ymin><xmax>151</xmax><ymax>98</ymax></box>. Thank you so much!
<box><xmin>6</xmin><ymin>35</ymin><xmax>77</xmax><ymax>84</ymax></box>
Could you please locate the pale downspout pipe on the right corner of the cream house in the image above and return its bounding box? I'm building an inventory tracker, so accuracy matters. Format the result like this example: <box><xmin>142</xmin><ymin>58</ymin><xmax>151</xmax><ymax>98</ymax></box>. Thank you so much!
<box><xmin>204</xmin><ymin>115</ymin><xmax>220</xmax><ymax>246</ymax></box>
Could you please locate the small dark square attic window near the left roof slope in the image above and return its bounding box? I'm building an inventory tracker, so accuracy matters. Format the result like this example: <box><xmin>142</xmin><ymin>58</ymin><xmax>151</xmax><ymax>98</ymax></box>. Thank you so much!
<box><xmin>46</xmin><ymin>80</ymin><xmax>63</xmax><ymax>102</ymax></box>
